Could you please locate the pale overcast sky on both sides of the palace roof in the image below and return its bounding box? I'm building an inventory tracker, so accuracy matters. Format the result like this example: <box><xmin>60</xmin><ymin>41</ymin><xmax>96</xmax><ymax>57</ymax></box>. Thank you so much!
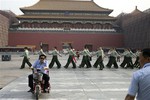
<box><xmin>0</xmin><ymin>0</ymin><xmax>150</xmax><ymax>16</ymax></box>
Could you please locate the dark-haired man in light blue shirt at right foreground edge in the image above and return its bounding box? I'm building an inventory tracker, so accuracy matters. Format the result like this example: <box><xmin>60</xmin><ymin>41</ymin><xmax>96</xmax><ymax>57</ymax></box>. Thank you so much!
<box><xmin>125</xmin><ymin>48</ymin><xmax>150</xmax><ymax>100</ymax></box>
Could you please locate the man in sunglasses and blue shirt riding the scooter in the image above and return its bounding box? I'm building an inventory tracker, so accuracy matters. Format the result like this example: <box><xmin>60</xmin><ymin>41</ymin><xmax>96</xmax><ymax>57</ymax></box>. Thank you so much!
<box><xmin>28</xmin><ymin>54</ymin><xmax>49</xmax><ymax>92</ymax></box>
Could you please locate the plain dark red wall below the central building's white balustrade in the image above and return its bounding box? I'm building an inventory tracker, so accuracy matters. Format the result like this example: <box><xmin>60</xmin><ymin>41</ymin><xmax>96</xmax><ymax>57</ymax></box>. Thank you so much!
<box><xmin>8</xmin><ymin>32</ymin><xmax>123</xmax><ymax>50</ymax></box>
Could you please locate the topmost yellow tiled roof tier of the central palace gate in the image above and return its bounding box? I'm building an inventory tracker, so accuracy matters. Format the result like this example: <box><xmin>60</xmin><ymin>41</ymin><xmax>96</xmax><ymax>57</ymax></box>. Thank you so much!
<box><xmin>20</xmin><ymin>0</ymin><xmax>113</xmax><ymax>12</ymax></box>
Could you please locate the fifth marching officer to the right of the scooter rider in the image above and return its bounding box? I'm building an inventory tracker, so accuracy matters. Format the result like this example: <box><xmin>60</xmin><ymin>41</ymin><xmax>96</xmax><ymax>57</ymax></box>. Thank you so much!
<box><xmin>106</xmin><ymin>48</ymin><xmax>120</xmax><ymax>69</ymax></box>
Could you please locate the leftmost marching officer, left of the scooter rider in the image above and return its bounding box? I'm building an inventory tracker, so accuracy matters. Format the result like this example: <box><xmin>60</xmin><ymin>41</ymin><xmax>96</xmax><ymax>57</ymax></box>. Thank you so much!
<box><xmin>20</xmin><ymin>47</ymin><xmax>32</xmax><ymax>69</ymax></box>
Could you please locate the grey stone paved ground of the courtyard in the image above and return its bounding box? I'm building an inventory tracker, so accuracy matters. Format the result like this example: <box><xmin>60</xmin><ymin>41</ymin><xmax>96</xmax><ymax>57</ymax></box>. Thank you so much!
<box><xmin>0</xmin><ymin>55</ymin><xmax>137</xmax><ymax>100</ymax></box>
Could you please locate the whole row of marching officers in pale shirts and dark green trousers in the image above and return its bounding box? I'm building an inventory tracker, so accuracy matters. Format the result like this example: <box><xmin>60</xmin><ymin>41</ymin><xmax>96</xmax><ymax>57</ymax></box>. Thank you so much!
<box><xmin>21</xmin><ymin>46</ymin><xmax>140</xmax><ymax>70</ymax></box>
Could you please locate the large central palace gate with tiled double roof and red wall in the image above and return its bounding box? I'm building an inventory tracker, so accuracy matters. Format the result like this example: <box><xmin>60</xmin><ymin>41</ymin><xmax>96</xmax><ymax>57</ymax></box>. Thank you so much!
<box><xmin>9</xmin><ymin>0</ymin><xmax>123</xmax><ymax>50</ymax></box>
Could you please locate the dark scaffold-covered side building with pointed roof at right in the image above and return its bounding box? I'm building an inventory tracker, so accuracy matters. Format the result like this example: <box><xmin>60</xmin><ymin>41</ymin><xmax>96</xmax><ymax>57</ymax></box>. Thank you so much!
<box><xmin>116</xmin><ymin>7</ymin><xmax>150</xmax><ymax>49</ymax></box>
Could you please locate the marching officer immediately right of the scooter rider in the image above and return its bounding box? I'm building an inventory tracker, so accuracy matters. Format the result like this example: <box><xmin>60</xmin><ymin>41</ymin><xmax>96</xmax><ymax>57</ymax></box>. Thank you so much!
<box><xmin>49</xmin><ymin>47</ymin><xmax>61</xmax><ymax>69</ymax></box>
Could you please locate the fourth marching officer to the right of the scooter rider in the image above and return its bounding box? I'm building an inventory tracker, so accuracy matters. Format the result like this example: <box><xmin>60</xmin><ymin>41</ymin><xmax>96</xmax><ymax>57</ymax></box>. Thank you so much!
<box><xmin>93</xmin><ymin>47</ymin><xmax>104</xmax><ymax>70</ymax></box>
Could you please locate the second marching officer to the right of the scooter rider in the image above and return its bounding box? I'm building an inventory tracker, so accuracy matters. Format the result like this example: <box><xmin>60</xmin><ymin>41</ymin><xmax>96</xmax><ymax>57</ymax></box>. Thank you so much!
<box><xmin>64</xmin><ymin>47</ymin><xmax>76</xmax><ymax>68</ymax></box>
